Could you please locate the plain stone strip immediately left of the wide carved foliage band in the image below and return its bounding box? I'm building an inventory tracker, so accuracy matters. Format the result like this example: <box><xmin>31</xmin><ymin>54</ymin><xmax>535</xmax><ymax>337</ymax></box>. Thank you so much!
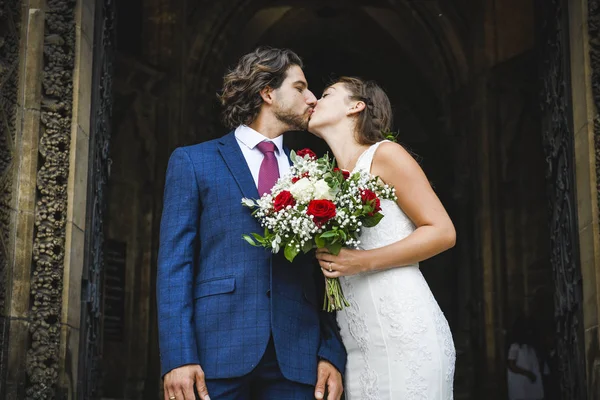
<box><xmin>4</xmin><ymin>1</ymin><xmax>46</xmax><ymax>399</ymax></box>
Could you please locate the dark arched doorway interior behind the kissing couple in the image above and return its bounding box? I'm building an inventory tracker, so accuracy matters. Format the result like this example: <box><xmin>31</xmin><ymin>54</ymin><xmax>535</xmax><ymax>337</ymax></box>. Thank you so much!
<box><xmin>99</xmin><ymin>0</ymin><xmax>551</xmax><ymax>396</ymax></box>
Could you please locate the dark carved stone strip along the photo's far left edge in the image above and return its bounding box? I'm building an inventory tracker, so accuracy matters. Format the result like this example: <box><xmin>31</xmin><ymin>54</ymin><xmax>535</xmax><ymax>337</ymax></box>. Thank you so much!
<box><xmin>0</xmin><ymin>0</ymin><xmax>21</xmax><ymax>398</ymax></box>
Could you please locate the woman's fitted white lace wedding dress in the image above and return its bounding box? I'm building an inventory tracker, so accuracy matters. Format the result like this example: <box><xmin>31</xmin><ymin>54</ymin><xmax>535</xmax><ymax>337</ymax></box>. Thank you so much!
<box><xmin>337</xmin><ymin>142</ymin><xmax>456</xmax><ymax>400</ymax></box>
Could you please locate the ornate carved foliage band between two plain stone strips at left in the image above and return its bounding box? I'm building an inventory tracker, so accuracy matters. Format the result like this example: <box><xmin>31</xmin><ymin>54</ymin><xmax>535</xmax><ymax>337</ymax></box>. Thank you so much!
<box><xmin>26</xmin><ymin>0</ymin><xmax>75</xmax><ymax>399</ymax></box>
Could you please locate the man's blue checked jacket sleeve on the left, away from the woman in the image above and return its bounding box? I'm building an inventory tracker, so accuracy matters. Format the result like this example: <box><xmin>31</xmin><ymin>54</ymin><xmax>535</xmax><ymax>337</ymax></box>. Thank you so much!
<box><xmin>156</xmin><ymin>148</ymin><xmax>201</xmax><ymax>376</ymax></box>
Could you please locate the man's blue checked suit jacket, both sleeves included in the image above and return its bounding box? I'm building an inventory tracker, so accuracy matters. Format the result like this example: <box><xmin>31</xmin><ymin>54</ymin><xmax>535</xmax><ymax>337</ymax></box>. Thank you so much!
<box><xmin>157</xmin><ymin>132</ymin><xmax>346</xmax><ymax>385</ymax></box>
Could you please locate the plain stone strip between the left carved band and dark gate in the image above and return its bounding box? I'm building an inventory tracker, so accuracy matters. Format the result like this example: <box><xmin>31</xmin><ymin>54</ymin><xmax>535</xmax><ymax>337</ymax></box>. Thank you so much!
<box><xmin>58</xmin><ymin>0</ymin><xmax>96</xmax><ymax>398</ymax></box>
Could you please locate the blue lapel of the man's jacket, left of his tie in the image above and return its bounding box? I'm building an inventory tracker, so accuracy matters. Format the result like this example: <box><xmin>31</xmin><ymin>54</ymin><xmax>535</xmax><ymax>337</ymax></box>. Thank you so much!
<box><xmin>218</xmin><ymin>132</ymin><xmax>260</xmax><ymax>201</ymax></box>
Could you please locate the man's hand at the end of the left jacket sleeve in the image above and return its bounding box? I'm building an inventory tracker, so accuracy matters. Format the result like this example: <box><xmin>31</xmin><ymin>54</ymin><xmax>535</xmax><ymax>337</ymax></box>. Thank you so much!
<box><xmin>164</xmin><ymin>364</ymin><xmax>210</xmax><ymax>400</ymax></box>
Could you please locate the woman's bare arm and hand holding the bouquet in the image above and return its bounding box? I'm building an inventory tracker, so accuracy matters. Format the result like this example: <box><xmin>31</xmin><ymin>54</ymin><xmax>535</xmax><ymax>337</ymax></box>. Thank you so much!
<box><xmin>317</xmin><ymin>143</ymin><xmax>456</xmax><ymax>277</ymax></box>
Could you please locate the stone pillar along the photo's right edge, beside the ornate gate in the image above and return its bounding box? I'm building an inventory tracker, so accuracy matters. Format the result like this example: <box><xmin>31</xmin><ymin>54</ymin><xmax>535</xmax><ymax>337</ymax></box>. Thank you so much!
<box><xmin>569</xmin><ymin>0</ymin><xmax>600</xmax><ymax>399</ymax></box>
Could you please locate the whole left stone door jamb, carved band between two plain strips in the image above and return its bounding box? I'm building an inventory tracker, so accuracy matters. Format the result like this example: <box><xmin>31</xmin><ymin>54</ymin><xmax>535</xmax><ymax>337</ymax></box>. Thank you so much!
<box><xmin>0</xmin><ymin>0</ymin><xmax>95</xmax><ymax>400</ymax></box>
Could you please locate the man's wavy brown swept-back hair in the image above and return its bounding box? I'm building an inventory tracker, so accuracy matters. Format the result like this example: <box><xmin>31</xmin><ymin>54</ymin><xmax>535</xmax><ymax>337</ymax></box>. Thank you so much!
<box><xmin>218</xmin><ymin>47</ymin><xmax>303</xmax><ymax>128</ymax></box>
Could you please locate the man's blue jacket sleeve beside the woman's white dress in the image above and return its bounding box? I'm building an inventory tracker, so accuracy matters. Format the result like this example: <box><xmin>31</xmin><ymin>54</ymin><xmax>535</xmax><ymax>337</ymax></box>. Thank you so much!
<box><xmin>315</xmin><ymin>264</ymin><xmax>346</xmax><ymax>376</ymax></box>
